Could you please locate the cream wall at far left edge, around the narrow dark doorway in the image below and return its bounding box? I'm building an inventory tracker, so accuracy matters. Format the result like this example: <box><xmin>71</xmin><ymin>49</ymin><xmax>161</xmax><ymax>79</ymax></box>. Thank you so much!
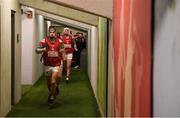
<box><xmin>0</xmin><ymin>0</ymin><xmax>21</xmax><ymax>116</ymax></box>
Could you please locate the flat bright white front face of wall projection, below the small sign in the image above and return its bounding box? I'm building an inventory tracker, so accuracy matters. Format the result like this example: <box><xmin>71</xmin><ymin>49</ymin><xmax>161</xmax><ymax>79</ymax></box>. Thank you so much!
<box><xmin>21</xmin><ymin>8</ymin><xmax>35</xmax><ymax>85</ymax></box>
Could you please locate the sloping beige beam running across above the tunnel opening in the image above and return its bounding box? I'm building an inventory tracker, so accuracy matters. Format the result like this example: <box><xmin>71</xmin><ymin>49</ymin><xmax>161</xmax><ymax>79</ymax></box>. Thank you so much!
<box><xmin>19</xmin><ymin>0</ymin><xmax>99</xmax><ymax>26</ymax></box>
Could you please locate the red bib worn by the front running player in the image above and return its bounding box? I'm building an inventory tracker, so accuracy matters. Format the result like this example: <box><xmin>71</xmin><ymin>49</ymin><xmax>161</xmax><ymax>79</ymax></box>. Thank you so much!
<box><xmin>40</xmin><ymin>37</ymin><xmax>62</xmax><ymax>66</ymax></box>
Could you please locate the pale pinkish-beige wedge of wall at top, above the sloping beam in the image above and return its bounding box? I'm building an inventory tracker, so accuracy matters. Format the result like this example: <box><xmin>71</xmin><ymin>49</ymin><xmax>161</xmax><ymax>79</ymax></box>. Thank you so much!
<box><xmin>49</xmin><ymin>0</ymin><xmax>113</xmax><ymax>18</ymax></box>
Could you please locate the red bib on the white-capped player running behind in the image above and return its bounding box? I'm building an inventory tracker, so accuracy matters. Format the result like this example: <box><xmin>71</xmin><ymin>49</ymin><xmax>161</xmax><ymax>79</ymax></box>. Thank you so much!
<box><xmin>61</xmin><ymin>35</ymin><xmax>74</xmax><ymax>53</ymax></box>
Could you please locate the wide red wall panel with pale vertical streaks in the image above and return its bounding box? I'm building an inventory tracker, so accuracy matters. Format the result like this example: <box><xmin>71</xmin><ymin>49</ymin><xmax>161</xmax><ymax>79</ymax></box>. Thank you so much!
<box><xmin>113</xmin><ymin>0</ymin><xmax>151</xmax><ymax>116</ymax></box>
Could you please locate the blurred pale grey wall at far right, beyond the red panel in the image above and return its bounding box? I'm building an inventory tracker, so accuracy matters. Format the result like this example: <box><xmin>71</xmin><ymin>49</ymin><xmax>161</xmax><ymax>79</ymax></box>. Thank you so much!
<box><xmin>153</xmin><ymin>0</ymin><xmax>180</xmax><ymax>117</ymax></box>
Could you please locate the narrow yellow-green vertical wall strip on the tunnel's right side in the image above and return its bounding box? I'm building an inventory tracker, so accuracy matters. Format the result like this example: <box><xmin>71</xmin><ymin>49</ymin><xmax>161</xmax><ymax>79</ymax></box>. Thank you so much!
<box><xmin>97</xmin><ymin>17</ymin><xmax>107</xmax><ymax>115</ymax></box>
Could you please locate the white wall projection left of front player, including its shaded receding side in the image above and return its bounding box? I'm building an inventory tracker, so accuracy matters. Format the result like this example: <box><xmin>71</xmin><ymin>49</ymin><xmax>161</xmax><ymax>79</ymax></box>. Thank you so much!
<box><xmin>21</xmin><ymin>7</ymin><xmax>45</xmax><ymax>85</ymax></box>
